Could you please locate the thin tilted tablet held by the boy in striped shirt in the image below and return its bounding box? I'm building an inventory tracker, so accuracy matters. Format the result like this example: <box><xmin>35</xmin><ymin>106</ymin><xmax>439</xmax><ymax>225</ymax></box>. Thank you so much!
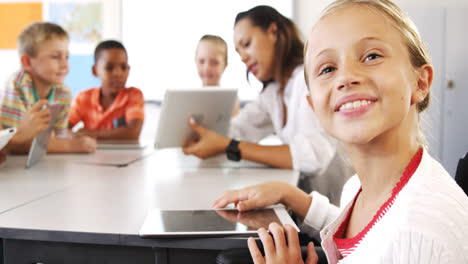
<box><xmin>26</xmin><ymin>104</ymin><xmax>62</xmax><ymax>168</ymax></box>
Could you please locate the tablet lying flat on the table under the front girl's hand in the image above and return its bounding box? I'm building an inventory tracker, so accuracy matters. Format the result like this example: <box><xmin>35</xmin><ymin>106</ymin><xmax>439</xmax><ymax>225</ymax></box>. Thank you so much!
<box><xmin>140</xmin><ymin>207</ymin><xmax>299</xmax><ymax>237</ymax></box>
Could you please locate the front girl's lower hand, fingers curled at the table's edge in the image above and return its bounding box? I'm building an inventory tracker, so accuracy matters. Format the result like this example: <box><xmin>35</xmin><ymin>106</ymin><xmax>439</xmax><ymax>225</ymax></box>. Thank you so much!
<box><xmin>248</xmin><ymin>223</ymin><xmax>318</xmax><ymax>264</ymax></box>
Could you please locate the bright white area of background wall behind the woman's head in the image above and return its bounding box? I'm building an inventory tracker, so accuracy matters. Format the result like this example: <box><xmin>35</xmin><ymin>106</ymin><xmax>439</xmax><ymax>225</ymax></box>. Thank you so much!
<box><xmin>122</xmin><ymin>0</ymin><xmax>293</xmax><ymax>100</ymax></box>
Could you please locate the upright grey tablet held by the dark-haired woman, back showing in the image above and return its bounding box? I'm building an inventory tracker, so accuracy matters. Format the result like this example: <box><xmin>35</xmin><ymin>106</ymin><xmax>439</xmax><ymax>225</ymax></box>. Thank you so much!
<box><xmin>154</xmin><ymin>87</ymin><xmax>237</xmax><ymax>148</ymax></box>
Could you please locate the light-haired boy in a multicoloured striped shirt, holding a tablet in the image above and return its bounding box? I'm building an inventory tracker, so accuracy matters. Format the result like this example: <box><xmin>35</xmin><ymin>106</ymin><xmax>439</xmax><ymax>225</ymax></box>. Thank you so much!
<box><xmin>0</xmin><ymin>22</ymin><xmax>96</xmax><ymax>153</ymax></box>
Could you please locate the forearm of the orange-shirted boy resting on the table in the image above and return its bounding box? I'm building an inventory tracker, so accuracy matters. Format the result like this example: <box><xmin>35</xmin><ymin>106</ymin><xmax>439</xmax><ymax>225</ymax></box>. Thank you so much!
<box><xmin>77</xmin><ymin>119</ymin><xmax>143</xmax><ymax>140</ymax></box>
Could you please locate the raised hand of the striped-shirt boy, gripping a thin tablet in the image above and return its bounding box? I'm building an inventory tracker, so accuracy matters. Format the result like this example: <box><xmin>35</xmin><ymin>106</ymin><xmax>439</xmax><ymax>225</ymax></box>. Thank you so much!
<box><xmin>17</xmin><ymin>100</ymin><xmax>50</xmax><ymax>142</ymax></box>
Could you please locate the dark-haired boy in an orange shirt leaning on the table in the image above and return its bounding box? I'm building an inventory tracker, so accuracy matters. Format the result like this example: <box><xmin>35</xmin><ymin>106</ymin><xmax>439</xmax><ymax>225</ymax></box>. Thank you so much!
<box><xmin>69</xmin><ymin>40</ymin><xmax>144</xmax><ymax>139</ymax></box>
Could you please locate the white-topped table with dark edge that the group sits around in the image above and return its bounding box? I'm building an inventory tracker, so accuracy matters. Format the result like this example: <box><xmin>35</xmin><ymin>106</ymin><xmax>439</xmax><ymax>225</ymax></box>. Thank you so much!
<box><xmin>0</xmin><ymin>149</ymin><xmax>298</xmax><ymax>263</ymax></box>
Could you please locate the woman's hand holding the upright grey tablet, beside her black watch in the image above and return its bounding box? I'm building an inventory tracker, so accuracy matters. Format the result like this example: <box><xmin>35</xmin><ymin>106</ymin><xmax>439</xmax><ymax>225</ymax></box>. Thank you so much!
<box><xmin>182</xmin><ymin>118</ymin><xmax>230</xmax><ymax>159</ymax></box>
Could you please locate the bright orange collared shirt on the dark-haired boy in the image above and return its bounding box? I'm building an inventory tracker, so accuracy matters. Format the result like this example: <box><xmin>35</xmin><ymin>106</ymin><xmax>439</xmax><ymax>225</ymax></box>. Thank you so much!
<box><xmin>69</xmin><ymin>87</ymin><xmax>145</xmax><ymax>130</ymax></box>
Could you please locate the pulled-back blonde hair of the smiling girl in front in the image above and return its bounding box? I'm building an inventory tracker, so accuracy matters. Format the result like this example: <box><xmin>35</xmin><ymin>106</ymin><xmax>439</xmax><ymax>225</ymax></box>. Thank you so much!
<box><xmin>320</xmin><ymin>0</ymin><xmax>432</xmax><ymax>113</ymax></box>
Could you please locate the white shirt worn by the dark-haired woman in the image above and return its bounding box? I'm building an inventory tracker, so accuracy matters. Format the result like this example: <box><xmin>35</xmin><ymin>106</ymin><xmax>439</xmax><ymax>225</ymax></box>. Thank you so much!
<box><xmin>229</xmin><ymin>65</ymin><xmax>353</xmax><ymax>204</ymax></box>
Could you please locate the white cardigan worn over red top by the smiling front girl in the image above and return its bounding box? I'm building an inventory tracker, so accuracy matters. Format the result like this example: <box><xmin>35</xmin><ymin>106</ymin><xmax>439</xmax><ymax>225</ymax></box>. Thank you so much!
<box><xmin>304</xmin><ymin>150</ymin><xmax>468</xmax><ymax>264</ymax></box>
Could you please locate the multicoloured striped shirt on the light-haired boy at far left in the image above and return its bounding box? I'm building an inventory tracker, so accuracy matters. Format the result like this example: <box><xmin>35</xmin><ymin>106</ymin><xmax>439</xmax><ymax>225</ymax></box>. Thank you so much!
<box><xmin>0</xmin><ymin>70</ymin><xmax>72</xmax><ymax>134</ymax></box>
